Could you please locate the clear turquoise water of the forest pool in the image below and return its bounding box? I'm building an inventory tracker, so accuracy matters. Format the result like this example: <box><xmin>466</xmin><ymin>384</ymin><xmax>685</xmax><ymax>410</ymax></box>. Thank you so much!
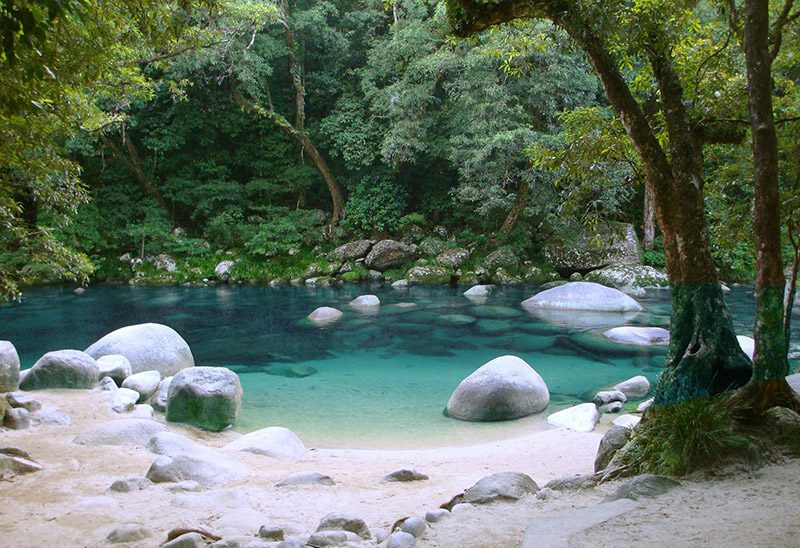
<box><xmin>0</xmin><ymin>286</ymin><xmax>768</xmax><ymax>447</ymax></box>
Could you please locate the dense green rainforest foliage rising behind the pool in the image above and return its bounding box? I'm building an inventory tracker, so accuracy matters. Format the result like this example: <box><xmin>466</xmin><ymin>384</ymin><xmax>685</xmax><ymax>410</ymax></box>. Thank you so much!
<box><xmin>0</xmin><ymin>0</ymin><xmax>800</xmax><ymax>296</ymax></box>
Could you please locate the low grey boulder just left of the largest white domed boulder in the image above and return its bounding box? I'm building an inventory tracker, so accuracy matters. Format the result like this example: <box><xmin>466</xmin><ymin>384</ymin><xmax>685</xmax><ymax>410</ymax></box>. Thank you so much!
<box><xmin>19</xmin><ymin>350</ymin><xmax>100</xmax><ymax>390</ymax></box>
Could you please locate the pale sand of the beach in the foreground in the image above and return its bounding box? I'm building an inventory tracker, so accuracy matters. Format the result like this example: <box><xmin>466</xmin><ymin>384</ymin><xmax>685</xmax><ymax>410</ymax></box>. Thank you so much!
<box><xmin>0</xmin><ymin>390</ymin><xmax>800</xmax><ymax>547</ymax></box>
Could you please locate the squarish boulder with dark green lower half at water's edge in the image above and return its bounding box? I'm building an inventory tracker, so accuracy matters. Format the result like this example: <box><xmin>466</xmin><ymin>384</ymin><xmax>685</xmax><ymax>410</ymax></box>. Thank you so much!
<box><xmin>167</xmin><ymin>367</ymin><xmax>242</xmax><ymax>432</ymax></box>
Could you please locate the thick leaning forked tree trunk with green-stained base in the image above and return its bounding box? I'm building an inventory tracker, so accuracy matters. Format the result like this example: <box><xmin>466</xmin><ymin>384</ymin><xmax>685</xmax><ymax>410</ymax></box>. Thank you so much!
<box><xmin>448</xmin><ymin>0</ymin><xmax>751</xmax><ymax>405</ymax></box>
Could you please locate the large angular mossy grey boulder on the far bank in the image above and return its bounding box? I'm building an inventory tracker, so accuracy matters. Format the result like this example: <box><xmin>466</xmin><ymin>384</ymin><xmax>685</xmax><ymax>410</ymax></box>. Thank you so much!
<box><xmin>544</xmin><ymin>223</ymin><xmax>639</xmax><ymax>277</ymax></box>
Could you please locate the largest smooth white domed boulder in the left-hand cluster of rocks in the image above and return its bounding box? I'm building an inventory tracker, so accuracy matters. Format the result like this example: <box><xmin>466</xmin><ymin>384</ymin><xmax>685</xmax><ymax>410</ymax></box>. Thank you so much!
<box><xmin>86</xmin><ymin>323</ymin><xmax>194</xmax><ymax>377</ymax></box>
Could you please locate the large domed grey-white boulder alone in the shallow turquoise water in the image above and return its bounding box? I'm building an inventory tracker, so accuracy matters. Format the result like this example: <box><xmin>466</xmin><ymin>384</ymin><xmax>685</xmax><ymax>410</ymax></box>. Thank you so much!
<box><xmin>447</xmin><ymin>356</ymin><xmax>550</xmax><ymax>421</ymax></box>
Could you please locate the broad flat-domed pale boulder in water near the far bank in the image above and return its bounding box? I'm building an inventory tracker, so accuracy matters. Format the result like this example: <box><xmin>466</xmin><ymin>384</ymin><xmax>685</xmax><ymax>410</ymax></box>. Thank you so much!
<box><xmin>522</xmin><ymin>282</ymin><xmax>643</xmax><ymax>312</ymax></box>
